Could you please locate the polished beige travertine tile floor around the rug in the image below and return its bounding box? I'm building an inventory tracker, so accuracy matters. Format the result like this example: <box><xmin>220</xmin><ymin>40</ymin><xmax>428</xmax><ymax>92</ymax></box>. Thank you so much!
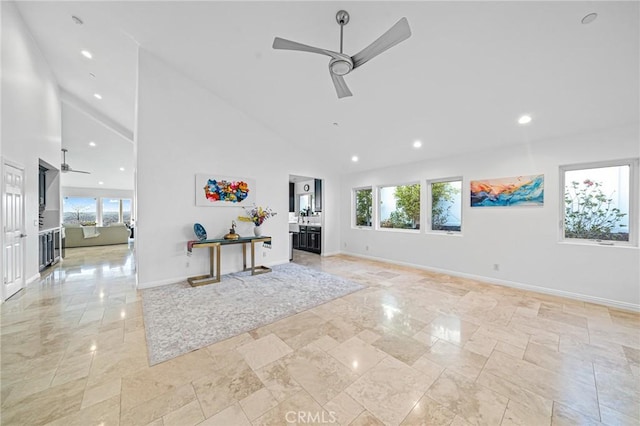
<box><xmin>0</xmin><ymin>245</ymin><xmax>640</xmax><ymax>426</ymax></box>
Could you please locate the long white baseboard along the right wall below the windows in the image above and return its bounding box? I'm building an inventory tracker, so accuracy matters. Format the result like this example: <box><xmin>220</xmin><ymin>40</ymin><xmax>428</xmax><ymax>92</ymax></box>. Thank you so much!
<box><xmin>340</xmin><ymin>251</ymin><xmax>640</xmax><ymax>312</ymax></box>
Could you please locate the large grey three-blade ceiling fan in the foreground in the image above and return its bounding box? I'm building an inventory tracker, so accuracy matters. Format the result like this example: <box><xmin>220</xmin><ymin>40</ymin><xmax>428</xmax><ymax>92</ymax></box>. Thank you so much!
<box><xmin>273</xmin><ymin>10</ymin><xmax>411</xmax><ymax>98</ymax></box>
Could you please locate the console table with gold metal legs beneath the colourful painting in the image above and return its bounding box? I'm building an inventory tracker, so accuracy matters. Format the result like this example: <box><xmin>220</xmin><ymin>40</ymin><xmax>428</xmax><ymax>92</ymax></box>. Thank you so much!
<box><xmin>187</xmin><ymin>236</ymin><xmax>271</xmax><ymax>287</ymax></box>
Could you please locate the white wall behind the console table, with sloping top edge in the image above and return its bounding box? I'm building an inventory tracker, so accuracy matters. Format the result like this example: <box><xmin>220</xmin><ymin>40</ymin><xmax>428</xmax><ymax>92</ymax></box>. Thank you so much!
<box><xmin>135</xmin><ymin>49</ymin><xmax>339</xmax><ymax>288</ymax></box>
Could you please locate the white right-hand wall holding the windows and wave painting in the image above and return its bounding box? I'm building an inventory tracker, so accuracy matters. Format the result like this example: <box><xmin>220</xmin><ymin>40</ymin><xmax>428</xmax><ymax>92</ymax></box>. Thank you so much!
<box><xmin>340</xmin><ymin>128</ymin><xmax>640</xmax><ymax>309</ymax></box>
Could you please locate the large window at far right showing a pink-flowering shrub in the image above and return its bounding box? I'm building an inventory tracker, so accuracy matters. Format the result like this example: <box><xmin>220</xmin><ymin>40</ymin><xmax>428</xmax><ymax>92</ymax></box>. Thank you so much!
<box><xmin>561</xmin><ymin>160</ymin><xmax>637</xmax><ymax>244</ymax></box>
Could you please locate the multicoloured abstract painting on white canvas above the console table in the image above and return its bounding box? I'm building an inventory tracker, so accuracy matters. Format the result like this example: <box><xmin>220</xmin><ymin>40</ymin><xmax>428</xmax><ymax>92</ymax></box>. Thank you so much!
<box><xmin>195</xmin><ymin>173</ymin><xmax>256</xmax><ymax>207</ymax></box>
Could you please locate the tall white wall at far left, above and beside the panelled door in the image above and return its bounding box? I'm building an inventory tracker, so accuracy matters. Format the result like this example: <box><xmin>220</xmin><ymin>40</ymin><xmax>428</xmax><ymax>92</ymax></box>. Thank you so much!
<box><xmin>0</xmin><ymin>1</ymin><xmax>61</xmax><ymax>280</ymax></box>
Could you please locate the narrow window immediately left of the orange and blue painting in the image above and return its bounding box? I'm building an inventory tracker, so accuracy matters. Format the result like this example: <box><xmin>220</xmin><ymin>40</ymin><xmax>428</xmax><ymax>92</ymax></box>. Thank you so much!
<box><xmin>429</xmin><ymin>179</ymin><xmax>462</xmax><ymax>232</ymax></box>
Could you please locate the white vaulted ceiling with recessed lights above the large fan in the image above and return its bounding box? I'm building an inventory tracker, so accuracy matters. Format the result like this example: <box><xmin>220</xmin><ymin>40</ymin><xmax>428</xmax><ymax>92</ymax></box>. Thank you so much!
<box><xmin>17</xmin><ymin>1</ymin><xmax>640</xmax><ymax>186</ymax></box>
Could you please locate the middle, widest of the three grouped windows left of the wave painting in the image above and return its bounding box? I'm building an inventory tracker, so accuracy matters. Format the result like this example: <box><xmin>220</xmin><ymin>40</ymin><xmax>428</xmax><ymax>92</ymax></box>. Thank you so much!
<box><xmin>379</xmin><ymin>183</ymin><xmax>420</xmax><ymax>229</ymax></box>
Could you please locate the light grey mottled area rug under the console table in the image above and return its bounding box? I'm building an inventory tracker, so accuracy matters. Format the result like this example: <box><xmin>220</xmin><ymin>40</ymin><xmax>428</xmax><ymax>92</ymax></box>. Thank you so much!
<box><xmin>142</xmin><ymin>263</ymin><xmax>364</xmax><ymax>365</ymax></box>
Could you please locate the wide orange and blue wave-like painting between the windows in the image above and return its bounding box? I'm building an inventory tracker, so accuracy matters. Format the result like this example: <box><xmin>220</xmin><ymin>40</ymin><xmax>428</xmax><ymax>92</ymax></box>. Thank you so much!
<box><xmin>471</xmin><ymin>175</ymin><xmax>544</xmax><ymax>207</ymax></box>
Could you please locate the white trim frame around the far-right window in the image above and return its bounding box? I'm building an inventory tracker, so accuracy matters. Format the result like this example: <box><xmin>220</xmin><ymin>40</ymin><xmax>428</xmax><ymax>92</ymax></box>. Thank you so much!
<box><xmin>558</xmin><ymin>158</ymin><xmax>640</xmax><ymax>247</ymax></box>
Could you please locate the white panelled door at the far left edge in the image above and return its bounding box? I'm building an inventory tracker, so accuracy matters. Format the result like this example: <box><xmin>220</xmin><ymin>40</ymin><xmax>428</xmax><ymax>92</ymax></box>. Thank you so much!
<box><xmin>2</xmin><ymin>163</ymin><xmax>26</xmax><ymax>300</ymax></box>
